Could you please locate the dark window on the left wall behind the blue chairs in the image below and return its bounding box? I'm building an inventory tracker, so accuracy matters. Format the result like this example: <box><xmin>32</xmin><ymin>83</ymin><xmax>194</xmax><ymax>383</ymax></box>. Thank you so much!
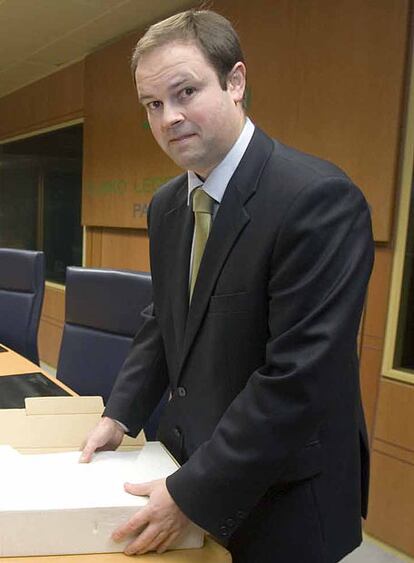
<box><xmin>0</xmin><ymin>125</ymin><xmax>82</xmax><ymax>283</ymax></box>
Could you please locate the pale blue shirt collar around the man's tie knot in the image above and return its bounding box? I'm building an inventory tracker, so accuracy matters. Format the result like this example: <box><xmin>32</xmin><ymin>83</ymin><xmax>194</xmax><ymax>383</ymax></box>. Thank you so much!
<box><xmin>187</xmin><ymin>117</ymin><xmax>254</xmax><ymax>205</ymax></box>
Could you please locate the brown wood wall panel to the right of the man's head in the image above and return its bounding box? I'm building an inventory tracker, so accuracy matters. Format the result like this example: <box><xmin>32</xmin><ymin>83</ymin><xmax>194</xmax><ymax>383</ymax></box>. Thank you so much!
<box><xmin>213</xmin><ymin>0</ymin><xmax>410</xmax><ymax>241</ymax></box>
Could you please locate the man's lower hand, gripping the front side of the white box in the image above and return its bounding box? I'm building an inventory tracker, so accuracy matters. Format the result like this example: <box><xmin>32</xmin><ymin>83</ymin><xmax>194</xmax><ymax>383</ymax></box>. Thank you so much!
<box><xmin>112</xmin><ymin>479</ymin><xmax>190</xmax><ymax>555</ymax></box>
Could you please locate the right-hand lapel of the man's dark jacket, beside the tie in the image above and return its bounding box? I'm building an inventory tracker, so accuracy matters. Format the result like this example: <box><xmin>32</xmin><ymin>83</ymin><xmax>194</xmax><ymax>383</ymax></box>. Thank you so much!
<box><xmin>180</xmin><ymin>128</ymin><xmax>273</xmax><ymax>371</ymax></box>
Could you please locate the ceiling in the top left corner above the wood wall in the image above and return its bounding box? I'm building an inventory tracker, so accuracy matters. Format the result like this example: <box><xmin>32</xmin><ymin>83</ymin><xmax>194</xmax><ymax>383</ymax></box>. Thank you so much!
<box><xmin>0</xmin><ymin>0</ymin><xmax>195</xmax><ymax>97</ymax></box>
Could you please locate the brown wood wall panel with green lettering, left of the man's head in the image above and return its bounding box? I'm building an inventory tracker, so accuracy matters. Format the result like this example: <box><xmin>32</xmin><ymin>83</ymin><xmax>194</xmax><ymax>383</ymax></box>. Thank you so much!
<box><xmin>82</xmin><ymin>34</ymin><xmax>181</xmax><ymax>229</ymax></box>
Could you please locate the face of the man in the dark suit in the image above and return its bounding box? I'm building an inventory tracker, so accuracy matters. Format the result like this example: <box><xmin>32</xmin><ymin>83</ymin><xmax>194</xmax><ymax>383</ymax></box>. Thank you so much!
<box><xmin>135</xmin><ymin>42</ymin><xmax>245</xmax><ymax>177</ymax></box>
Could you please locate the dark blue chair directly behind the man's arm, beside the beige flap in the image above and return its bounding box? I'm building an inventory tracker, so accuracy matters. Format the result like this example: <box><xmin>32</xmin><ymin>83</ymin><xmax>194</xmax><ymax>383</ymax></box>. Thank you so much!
<box><xmin>57</xmin><ymin>267</ymin><xmax>167</xmax><ymax>440</ymax></box>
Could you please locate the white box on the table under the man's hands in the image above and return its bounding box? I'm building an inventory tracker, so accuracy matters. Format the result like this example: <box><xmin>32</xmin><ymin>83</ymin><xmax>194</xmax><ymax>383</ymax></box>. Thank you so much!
<box><xmin>0</xmin><ymin>442</ymin><xmax>203</xmax><ymax>556</ymax></box>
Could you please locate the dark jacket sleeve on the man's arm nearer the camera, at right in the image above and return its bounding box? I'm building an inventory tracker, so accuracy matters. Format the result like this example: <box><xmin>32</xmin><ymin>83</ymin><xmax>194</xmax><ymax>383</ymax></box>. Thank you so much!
<box><xmin>167</xmin><ymin>177</ymin><xmax>373</xmax><ymax>537</ymax></box>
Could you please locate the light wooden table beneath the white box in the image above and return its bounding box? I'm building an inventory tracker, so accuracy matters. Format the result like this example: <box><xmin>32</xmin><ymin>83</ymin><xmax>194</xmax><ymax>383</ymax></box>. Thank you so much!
<box><xmin>0</xmin><ymin>346</ymin><xmax>231</xmax><ymax>563</ymax></box>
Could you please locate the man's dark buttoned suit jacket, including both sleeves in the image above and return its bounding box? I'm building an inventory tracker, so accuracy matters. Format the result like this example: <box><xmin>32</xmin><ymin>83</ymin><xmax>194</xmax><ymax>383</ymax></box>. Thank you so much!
<box><xmin>105</xmin><ymin>129</ymin><xmax>373</xmax><ymax>563</ymax></box>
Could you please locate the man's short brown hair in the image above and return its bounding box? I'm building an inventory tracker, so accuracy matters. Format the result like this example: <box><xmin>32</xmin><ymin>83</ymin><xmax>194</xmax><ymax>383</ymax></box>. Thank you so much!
<box><xmin>131</xmin><ymin>9</ymin><xmax>245</xmax><ymax>102</ymax></box>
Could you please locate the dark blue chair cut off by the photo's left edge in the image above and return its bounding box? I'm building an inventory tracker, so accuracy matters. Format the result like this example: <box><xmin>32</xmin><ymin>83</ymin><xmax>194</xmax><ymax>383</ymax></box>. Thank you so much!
<box><xmin>0</xmin><ymin>248</ymin><xmax>45</xmax><ymax>364</ymax></box>
